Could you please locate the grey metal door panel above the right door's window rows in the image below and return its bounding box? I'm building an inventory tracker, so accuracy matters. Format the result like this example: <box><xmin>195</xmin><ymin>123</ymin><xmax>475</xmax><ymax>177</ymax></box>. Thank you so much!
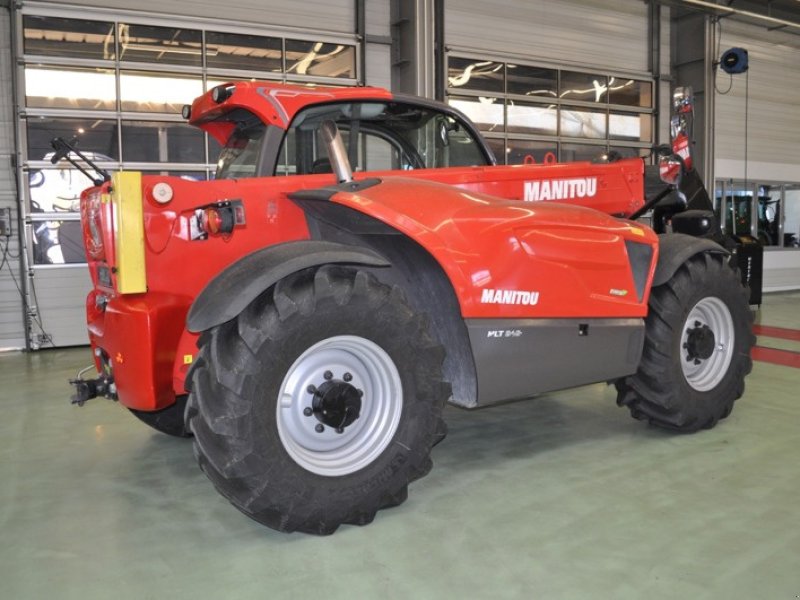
<box><xmin>445</xmin><ymin>0</ymin><xmax>649</xmax><ymax>72</ymax></box>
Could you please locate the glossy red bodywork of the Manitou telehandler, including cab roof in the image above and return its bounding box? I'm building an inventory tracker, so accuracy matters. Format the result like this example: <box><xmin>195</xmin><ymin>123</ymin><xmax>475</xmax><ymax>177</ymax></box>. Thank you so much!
<box><xmin>82</xmin><ymin>83</ymin><xmax>657</xmax><ymax>410</ymax></box>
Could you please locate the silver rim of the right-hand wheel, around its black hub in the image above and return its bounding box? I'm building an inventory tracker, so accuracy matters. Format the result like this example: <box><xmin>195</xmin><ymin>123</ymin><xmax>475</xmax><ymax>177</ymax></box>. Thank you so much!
<box><xmin>681</xmin><ymin>297</ymin><xmax>735</xmax><ymax>392</ymax></box>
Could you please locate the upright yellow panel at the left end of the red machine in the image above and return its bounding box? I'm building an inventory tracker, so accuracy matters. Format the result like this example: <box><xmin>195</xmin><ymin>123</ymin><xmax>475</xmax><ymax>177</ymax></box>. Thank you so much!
<box><xmin>111</xmin><ymin>171</ymin><xmax>147</xmax><ymax>294</ymax></box>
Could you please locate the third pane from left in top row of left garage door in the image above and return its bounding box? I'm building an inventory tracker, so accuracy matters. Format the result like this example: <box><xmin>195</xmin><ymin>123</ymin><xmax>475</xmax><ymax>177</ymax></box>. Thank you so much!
<box><xmin>206</xmin><ymin>31</ymin><xmax>283</xmax><ymax>73</ymax></box>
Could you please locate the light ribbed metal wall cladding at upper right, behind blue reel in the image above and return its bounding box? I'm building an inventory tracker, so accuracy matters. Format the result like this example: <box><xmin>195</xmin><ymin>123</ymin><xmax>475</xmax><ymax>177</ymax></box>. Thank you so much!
<box><xmin>715</xmin><ymin>21</ymin><xmax>800</xmax><ymax>181</ymax></box>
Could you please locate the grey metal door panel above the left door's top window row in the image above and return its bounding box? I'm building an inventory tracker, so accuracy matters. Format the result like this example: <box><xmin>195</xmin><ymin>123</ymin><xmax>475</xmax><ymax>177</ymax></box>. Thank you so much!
<box><xmin>46</xmin><ymin>0</ymin><xmax>355</xmax><ymax>33</ymax></box>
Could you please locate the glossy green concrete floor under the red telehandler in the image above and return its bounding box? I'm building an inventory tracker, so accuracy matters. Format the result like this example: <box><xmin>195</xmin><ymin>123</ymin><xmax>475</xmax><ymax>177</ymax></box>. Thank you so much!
<box><xmin>0</xmin><ymin>294</ymin><xmax>800</xmax><ymax>600</ymax></box>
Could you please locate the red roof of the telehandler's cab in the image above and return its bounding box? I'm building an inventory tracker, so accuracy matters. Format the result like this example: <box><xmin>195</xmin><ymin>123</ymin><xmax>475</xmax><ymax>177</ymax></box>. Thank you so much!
<box><xmin>189</xmin><ymin>81</ymin><xmax>392</xmax><ymax>134</ymax></box>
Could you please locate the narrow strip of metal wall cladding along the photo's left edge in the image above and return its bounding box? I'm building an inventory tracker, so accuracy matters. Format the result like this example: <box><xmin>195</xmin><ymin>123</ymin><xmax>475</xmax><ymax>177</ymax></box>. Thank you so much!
<box><xmin>0</xmin><ymin>5</ymin><xmax>25</xmax><ymax>348</ymax></box>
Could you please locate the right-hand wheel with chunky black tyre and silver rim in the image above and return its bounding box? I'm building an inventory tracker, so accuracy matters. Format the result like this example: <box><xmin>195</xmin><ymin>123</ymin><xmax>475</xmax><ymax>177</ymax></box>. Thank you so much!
<box><xmin>616</xmin><ymin>254</ymin><xmax>755</xmax><ymax>432</ymax></box>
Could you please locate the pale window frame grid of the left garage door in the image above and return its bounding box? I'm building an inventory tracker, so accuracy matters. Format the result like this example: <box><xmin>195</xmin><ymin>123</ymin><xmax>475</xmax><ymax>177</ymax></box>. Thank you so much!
<box><xmin>16</xmin><ymin>3</ymin><xmax>365</xmax><ymax>268</ymax></box>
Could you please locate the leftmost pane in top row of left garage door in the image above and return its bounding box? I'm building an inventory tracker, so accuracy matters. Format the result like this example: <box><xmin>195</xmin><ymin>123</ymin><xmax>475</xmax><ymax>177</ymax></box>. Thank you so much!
<box><xmin>22</xmin><ymin>15</ymin><xmax>116</xmax><ymax>60</ymax></box>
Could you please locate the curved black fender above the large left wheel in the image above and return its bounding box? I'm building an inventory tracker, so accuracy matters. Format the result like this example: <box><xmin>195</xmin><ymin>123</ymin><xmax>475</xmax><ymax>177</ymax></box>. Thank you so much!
<box><xmin>186</xmin><ymin>240</ymin><xmax>390</xmax><ymax>333</ymax></box>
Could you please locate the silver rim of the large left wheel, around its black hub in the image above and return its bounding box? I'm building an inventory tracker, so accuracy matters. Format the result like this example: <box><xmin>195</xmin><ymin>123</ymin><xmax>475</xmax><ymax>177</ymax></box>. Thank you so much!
<box><xmin>276</xmin><ymin>335</ymin><xmax>403</xmax><ymax>477</ymax></box>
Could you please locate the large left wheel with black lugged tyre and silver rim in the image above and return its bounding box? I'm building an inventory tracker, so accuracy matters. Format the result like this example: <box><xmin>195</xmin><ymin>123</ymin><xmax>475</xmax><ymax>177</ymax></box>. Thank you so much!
<box><xmin>186</xmin><ymin>266</ymin><xmax>450</xmax><ymax>535</ymax></box>
